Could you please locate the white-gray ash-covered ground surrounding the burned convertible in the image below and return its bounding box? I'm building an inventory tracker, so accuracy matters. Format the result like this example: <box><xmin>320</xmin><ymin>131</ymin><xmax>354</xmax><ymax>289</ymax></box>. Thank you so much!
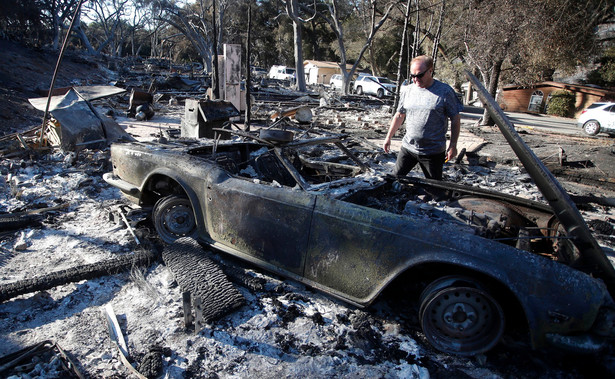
<box><xmin>0</xmin><ymin>41</ymin><xmax>615</xmax><ymax>378</ymax></box>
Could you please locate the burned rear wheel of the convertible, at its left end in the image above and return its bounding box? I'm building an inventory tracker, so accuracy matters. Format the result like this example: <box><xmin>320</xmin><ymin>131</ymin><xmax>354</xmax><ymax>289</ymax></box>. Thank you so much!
<box><xmin>152</xmin><ymin>195</ymin><xmax>196</xmax><ymax>243</ymax></box>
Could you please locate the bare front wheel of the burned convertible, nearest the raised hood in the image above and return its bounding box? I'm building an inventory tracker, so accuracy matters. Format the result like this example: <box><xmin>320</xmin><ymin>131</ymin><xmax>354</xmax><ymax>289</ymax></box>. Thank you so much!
<box><xmin>419</xmin><ymin>277</ymin><xmax>504</xmax><ymax>355</ymax></box>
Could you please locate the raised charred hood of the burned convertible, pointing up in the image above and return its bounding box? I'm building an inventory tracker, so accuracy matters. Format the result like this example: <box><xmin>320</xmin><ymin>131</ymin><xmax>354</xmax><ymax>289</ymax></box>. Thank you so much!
<box><xmin>466</xmin><ymin>71</ymin><xmax>615</xmax><ymax>293</ymax></box>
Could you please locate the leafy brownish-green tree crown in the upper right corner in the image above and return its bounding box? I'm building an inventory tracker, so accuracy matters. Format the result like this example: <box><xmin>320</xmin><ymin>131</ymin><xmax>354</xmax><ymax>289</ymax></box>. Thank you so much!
<box><xmin>454</xmin><ymin>0</ymin><xmax>613</xmax><ymax>124</ymax></box>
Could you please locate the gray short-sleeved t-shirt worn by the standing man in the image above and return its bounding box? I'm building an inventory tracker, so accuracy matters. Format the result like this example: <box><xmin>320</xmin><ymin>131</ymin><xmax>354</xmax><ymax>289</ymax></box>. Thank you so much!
<box><xmin>397</xmin><ymin>79</ymin><xmax>463</xmax><ymax>155</ymax></box>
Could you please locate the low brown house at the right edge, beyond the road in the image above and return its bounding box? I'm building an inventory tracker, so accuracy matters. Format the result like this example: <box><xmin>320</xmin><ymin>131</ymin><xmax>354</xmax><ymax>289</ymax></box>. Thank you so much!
<box><xmin>498</xmin><ymin>82</ymin><xmax>615</xmax><ymax>117</ymax></box>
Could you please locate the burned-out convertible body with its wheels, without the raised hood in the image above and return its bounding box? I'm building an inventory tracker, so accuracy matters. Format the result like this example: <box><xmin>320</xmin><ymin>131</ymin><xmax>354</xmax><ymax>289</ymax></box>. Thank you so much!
<box><xmin>105</xmin><ymin>77</ymin><xmax>615</xmax><ymax>355</ymax></box>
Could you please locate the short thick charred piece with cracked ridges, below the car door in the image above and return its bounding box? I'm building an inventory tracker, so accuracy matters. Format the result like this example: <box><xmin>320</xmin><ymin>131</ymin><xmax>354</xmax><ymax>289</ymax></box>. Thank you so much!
<box><xmin>162</xmin><ymin>237</ymin><xmax>245</xmax><ymax>323</ymax></box>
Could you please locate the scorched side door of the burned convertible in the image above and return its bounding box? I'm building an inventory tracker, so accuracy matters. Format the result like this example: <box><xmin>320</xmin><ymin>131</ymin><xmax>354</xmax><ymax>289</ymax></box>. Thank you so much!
<box><xmin>206</xmin><ymin>173</ymin><xmax>315</xmax><ymax>275</ymax></box>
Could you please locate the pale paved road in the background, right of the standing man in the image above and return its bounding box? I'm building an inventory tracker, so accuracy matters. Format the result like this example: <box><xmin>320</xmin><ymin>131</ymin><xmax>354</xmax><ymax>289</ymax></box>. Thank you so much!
<box><xmin>461</xmin><ymin>106</ymin><xmax>586</xmax><ymax>136</ymax></box>
